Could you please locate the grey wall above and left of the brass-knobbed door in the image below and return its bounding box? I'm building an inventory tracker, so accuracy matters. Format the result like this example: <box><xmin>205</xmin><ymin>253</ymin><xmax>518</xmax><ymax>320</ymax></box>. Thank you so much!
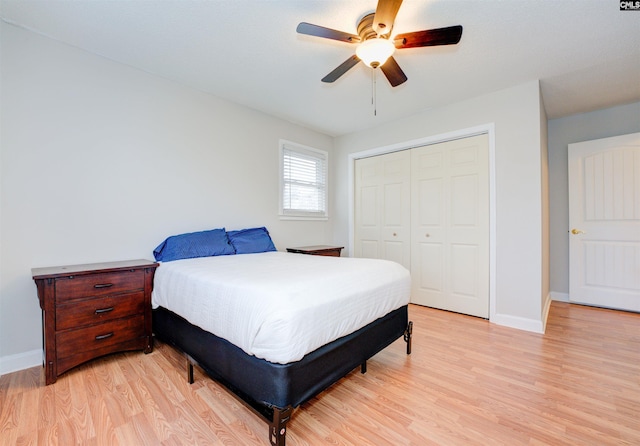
<box><xmin>549</xmin><ymin>102</ymin><xmax>640</xmax><ymax>300</ymax></box>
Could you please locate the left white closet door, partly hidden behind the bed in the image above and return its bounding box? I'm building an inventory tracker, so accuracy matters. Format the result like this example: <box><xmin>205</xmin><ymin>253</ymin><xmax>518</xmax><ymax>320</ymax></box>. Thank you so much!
<box><xmin>354</xmin><ymin>151</ymin><xmax>411</xmax><ymax>269</ymax></box>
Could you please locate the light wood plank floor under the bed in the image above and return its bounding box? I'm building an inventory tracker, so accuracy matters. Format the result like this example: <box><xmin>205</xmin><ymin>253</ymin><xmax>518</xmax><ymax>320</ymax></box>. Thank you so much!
<box><xmin>0</xmin><ymin>302</ymin><xmax>640</xmax><ymax>446</ymax></box>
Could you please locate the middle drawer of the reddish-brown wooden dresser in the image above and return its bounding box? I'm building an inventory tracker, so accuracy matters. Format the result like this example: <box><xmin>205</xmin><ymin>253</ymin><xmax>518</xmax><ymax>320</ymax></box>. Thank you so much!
<box><xmin>56</xmin><ymin>291</ymin><xmax>145</xmax><ymax>330</ymax></box>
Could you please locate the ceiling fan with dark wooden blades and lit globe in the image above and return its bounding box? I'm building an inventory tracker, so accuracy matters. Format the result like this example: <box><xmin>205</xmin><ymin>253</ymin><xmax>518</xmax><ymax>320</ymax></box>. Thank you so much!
<box><xmin>296</xmin><ymin>0</ymin><xmax>462</xmax><ymax>87</ymax></box>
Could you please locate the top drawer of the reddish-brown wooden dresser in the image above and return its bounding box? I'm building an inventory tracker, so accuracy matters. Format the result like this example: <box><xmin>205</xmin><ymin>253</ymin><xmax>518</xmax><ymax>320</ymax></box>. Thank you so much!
<box><xmin>56</xmin><ymin>269</ymin><xmax>144</xmax><ymax>303</ymax></box>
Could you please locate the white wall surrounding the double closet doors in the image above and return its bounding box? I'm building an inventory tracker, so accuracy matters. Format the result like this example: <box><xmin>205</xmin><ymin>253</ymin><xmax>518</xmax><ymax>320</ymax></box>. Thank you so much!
<box><xmin>333</xmin><ymin>82</ymin><xmax>544</xmax><ymax>331</ymax></box>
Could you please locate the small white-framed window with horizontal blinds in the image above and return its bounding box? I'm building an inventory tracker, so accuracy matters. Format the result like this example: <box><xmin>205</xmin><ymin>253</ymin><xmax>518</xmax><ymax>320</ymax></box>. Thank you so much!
<box><xmin>280</xmin><ymin>141</ymin><xmax>328</xmax><ymax>219</ymax></box>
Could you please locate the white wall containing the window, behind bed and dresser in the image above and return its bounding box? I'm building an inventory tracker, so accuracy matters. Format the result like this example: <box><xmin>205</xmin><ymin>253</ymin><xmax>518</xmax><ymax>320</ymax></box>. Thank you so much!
<box><xmin>0</xmin><ymin>22</ymin><xmax>333</xmax><ymax>373</ymax></box>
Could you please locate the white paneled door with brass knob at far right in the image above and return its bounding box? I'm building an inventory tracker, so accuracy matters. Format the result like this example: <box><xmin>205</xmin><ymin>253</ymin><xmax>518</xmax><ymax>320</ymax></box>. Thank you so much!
<box><xmin>569</xmin><ymin>133</ymin><xmax>640</xmax><ymax>311</ymax></box>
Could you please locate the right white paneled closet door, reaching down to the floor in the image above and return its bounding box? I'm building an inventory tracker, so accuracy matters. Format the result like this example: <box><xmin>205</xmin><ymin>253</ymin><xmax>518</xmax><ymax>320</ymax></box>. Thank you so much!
<box><xmin>411</xmin><ymin>135</ymin><xmax>489</xmax><ymax>318</ymax></box>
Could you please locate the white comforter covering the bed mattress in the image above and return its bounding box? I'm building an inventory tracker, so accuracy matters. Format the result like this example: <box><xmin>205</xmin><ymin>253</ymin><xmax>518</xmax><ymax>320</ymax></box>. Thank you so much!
<box><xmin>152</xmin><ymin>252</ymin><xmax>411</xmax><ymax>364</ymax></box>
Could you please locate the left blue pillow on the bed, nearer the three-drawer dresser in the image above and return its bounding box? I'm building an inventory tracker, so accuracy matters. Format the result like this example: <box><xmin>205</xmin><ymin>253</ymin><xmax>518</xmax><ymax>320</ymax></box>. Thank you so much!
<box><xmin>153</xmin><ymin>228</ymin><xmax>236</xmax><ymax>262</ymax></box>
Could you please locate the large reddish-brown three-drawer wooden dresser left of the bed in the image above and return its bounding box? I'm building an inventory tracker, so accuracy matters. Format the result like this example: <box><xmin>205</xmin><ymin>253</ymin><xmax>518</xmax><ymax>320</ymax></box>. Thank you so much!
<box><xmin>31</xmin><ymin>260</ymin><xmax>158</xmax><ymax>384</ymax></box>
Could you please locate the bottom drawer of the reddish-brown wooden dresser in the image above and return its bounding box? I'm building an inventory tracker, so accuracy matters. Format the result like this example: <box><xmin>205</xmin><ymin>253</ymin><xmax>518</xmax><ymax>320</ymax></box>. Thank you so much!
<box><xmin>56</xmin><ymin>315</ymin><xmax>145</xmax><ymax>358</ymax></box>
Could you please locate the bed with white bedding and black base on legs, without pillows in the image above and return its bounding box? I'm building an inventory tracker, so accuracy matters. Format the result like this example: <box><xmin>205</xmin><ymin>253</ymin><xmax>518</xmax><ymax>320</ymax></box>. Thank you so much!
<box><xmin>152</xmin><ymin>228</ymin><xmax>412</xmax><ymax>446</ymax></box>
